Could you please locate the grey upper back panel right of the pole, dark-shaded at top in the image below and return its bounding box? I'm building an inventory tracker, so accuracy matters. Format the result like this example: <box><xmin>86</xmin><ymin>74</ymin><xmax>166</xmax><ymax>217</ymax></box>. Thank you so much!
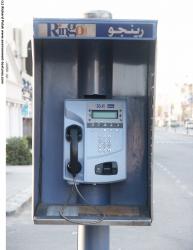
<box><xmin>113</xmin><ymin>41</ymin><xmax>148</xmax><ymax>97</ymax></box>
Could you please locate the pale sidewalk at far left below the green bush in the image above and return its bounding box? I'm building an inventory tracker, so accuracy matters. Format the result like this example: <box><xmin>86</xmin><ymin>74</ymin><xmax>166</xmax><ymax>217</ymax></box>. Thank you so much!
<box><xmin>6</xmin><ymin>166</ymin><xmax>32</xmax><ymax>215</ymax></box>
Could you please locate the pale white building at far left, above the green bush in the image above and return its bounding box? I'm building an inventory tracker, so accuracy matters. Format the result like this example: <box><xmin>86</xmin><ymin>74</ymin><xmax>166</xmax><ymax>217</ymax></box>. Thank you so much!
<box><xmin>6</xmin><ymin>24</ymin><xmax>32</xmax><ymax>138</ymax></box>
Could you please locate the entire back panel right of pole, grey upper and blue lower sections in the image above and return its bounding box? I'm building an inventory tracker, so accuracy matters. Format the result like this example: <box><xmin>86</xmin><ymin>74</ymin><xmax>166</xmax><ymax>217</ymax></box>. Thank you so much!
<box><xmin>111</xmin><ymin>41</ymin><xmax>148</xmax><ymax>205</ymax></box>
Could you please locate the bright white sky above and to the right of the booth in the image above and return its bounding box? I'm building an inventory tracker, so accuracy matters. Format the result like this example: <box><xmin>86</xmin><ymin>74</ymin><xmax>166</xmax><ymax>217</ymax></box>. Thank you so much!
<box><xmin>6</xmin><ymin>0</ymin><xmax>193</xmax><ymax>95</ymax></box>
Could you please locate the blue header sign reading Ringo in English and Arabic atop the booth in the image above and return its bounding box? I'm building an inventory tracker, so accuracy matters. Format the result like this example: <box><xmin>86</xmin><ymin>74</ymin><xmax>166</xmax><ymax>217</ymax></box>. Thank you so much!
<box><xmin>33</xmin><ymin>18</ymin><xmax>157</xmax><ymax>40</ymax></box>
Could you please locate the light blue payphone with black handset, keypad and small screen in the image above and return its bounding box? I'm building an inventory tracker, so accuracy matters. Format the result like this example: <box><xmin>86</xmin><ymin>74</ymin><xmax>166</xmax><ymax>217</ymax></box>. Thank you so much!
<box><xmin>63</xmin><ymin>99</ymin><xmax>127</xmax><ymax>183</ymax></box>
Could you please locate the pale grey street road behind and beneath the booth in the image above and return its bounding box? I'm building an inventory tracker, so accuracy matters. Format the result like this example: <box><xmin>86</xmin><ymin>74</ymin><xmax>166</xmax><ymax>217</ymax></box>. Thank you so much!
<box><xmin>7</xmin><ymin>129</ymin><xmax>193</xmax><ymax>250</ymax></box>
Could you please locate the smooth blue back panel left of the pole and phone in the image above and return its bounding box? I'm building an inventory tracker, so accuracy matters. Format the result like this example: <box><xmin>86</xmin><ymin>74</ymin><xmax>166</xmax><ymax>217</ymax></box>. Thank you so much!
<box><xmin>42</xmin><ymin>40</ymin><xmax>78</xmax><ymax>204</ymax></box>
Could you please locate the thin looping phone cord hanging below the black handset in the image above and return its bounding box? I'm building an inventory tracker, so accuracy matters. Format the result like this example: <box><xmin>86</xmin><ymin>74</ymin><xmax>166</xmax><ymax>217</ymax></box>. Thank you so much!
<box><xmin>59</xmin><ymin>177</ymin><xmax>105</xmax><ymax>225</ymax></box>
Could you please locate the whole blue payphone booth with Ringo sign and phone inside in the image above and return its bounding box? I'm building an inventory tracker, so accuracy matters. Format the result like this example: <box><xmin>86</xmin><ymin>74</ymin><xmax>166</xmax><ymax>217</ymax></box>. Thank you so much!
<box><xmin>33</xmin><ymin>19</ymin><xmax>157</xmax><ymax>229</ymax></box>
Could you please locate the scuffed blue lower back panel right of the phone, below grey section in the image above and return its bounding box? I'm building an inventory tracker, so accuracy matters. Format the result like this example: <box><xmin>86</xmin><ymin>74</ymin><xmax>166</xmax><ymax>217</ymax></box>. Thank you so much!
<box><xmin>111</xmin><ymin>97</ymin><xmax>148</xmax><ymax>207</ymax></box>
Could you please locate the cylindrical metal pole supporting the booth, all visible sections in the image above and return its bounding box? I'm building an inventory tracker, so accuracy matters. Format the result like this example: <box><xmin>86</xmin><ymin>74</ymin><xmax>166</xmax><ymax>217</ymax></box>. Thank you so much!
<box><xmin>78</xmin><ymin>10</ymin><xmax>112</xmax><ymax>250</ymax></box>
